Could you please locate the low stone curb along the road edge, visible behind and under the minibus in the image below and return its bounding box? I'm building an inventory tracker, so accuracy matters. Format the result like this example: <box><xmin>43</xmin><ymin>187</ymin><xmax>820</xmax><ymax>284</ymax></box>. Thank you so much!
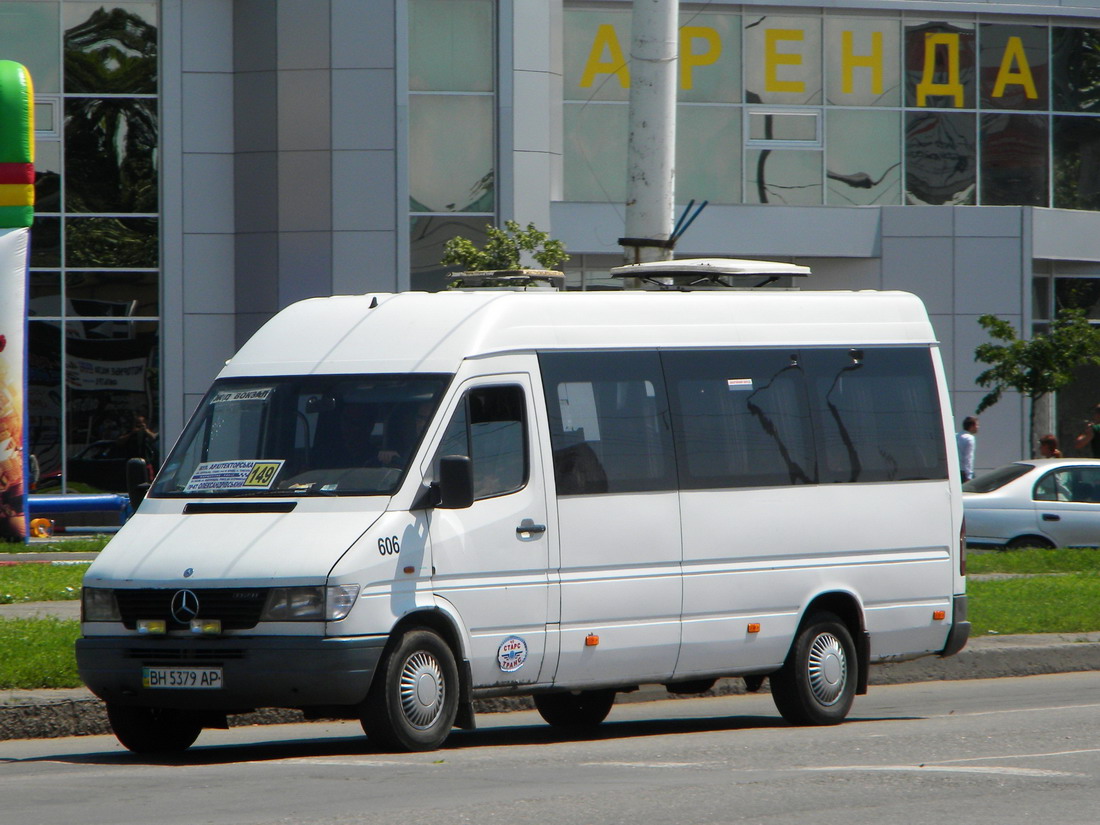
<box><xmin>0</xmin><ymin>634</ymin><xmax>1100</xmax><ymax>740</ymax></box>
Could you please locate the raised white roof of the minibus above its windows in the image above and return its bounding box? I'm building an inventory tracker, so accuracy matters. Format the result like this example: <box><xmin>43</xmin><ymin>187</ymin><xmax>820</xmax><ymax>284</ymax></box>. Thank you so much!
<box><xmin>221</xmin><ymin>289</ymin><xmax>935</xmax><ymax>376</ymax></box>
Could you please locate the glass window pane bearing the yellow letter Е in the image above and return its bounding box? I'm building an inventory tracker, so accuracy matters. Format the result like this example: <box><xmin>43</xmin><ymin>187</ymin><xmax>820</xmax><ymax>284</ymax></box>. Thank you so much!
<box><xmin>743</xmin><ymin>13</ymin><xmax>822</xmax><ymax>106</ymax></box>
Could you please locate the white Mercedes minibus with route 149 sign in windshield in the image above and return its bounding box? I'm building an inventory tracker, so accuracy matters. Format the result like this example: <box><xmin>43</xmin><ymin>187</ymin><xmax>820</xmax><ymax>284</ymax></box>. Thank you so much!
<box><xmin>77</xmin><ymin>289</ymin><xmax>969</xmax><ymax>752</ymax></box>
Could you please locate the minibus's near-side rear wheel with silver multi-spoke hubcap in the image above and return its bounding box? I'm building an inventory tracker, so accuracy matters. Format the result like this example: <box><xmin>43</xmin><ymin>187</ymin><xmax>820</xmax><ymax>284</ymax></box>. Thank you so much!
<box><xmin>769</xmin><ymin>613</ymin><xmax>858</xmax><ymax>725</ymax></box>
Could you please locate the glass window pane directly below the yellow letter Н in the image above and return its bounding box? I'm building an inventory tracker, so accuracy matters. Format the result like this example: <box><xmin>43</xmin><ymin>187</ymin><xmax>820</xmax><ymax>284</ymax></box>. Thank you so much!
<box><xmin>825</xmin><ymin>109</ymin><xmax>901</xmax><ymax>206</ymax></box>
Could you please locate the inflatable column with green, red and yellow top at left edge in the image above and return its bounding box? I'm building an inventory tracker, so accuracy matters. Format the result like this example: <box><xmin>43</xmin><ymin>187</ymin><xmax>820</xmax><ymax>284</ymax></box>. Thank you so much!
<box><xmin>0</xmin><ymin>61</ymin><xmax>34</xmax><ymax>541</ymax></box>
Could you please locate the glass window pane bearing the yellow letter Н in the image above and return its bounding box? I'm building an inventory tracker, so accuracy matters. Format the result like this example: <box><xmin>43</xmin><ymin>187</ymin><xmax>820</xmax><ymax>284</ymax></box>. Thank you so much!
<box><xmin>825</xmin><ymin>18</ymin><xmax>901</xmax><ymax>106</ymax></box>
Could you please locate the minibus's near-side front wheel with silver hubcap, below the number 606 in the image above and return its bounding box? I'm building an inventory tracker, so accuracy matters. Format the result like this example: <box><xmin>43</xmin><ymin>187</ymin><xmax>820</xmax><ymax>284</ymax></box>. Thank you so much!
<box><xmin>361</xmin><ymin>630</ymin><xmax>459</xmax><ymax>751</ymax></box>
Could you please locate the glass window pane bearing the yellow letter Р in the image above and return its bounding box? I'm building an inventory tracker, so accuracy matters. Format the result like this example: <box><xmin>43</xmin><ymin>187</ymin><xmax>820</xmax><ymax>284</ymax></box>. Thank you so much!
<box><xmin>678</xmin><ymin>10</ymin><xmax>741</xmax><ymax>103</ymax></box>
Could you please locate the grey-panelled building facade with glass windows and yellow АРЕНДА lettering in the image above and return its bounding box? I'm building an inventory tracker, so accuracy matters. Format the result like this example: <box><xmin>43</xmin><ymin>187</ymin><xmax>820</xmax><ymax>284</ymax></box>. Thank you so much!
<box><xmin>0</xmin><ymin>0</ymin><xmax>1100</xmax><ymax>488</ymax></box>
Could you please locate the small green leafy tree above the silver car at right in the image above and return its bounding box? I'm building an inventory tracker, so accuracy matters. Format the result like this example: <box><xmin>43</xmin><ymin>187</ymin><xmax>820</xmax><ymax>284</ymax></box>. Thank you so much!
<box><xmin>974</xmin><ymin>309</ymin><xmax>1100</xmax><ymax>442</ymax></box>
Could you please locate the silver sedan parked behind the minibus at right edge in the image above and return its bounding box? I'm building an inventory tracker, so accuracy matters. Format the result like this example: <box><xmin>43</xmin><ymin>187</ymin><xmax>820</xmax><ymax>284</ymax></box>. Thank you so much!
<box><xmin>963</xmin><ymin>459</ymin><xmax>1100</xmax><ymax>549</ymax></box>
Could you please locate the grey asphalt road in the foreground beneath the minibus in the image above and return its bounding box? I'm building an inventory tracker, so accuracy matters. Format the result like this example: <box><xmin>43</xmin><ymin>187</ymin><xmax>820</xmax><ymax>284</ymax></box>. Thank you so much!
<box><xmin>0</xmin><ymin>672</ymin><xmax>1100</xmax><ymax>825</ymax></box>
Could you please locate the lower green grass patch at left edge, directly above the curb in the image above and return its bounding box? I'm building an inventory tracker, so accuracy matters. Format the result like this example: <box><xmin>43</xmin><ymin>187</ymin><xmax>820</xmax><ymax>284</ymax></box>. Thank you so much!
<box><xmin>0</xmin><ymin>618</ymin><xmax>81</xmax><ymax>690</ymax></box>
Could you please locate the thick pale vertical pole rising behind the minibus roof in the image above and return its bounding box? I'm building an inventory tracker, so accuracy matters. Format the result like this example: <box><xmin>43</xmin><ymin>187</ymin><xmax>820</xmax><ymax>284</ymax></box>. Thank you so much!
<box><xmin>619</xmin><ymin>0</ymin><xmax>679</xmax><ymax>268</ymax></box>
